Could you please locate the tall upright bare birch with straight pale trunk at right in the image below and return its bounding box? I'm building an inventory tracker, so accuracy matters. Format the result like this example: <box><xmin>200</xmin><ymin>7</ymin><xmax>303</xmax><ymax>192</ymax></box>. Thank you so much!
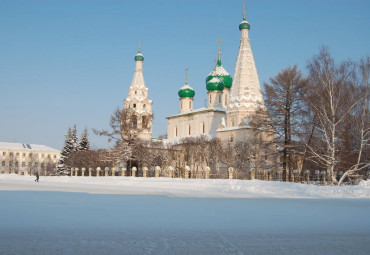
<box><xmin>307</xmin><ymin>47</ymin><xmax>363</xmax><ymax>184</ymax></box>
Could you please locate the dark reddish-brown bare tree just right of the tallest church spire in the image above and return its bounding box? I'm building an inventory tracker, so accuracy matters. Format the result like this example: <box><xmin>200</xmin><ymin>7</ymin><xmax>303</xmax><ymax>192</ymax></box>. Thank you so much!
<box><xmin>251</xmin><ymin>65</ymin><xmax>308</xmax><ymax>181</ymax></box>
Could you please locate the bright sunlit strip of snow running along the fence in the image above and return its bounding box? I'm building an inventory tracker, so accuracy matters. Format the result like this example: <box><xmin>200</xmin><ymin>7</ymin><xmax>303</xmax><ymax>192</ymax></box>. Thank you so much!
<box><xmin>0</xmin><ymin>175</ymin><xmax>370</xmax><ymax>198</ymax></box>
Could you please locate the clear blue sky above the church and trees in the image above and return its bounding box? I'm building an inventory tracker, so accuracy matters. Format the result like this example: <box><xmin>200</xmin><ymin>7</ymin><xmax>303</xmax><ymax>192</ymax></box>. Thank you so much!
<box><xmin>0</xmin><ymin>0</ymin><xmax>370</xmax><ymax>149</ymax></box>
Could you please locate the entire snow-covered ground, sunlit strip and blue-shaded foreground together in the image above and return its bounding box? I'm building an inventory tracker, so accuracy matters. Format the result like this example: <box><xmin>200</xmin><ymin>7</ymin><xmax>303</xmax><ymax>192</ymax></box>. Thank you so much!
<box><xmin>0</xmin><ymin>175</ymin><xmax>370</xmax><ymax>255</ymax></box>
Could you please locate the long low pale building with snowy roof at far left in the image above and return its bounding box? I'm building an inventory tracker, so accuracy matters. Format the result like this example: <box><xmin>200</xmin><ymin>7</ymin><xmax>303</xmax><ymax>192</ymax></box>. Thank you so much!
<box><xmin>0</xmin><ymin>142</ymin><xmax>60</xmax><ymax>175</ymax></box>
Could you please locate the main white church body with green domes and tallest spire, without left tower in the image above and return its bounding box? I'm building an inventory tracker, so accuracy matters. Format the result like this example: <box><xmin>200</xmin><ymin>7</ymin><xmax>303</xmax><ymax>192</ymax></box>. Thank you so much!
<box><xmin>167</xmin><ymin>8</ymin><xmax>264</xmax><ymax>142</ymax></box>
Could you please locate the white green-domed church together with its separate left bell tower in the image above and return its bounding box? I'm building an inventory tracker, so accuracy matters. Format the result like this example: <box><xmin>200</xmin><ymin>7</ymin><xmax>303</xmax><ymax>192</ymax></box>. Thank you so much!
<box><xmin>124</xmin><ymin>7</ymin><xmax>264</xmax><ymax>142</ymax></box>
